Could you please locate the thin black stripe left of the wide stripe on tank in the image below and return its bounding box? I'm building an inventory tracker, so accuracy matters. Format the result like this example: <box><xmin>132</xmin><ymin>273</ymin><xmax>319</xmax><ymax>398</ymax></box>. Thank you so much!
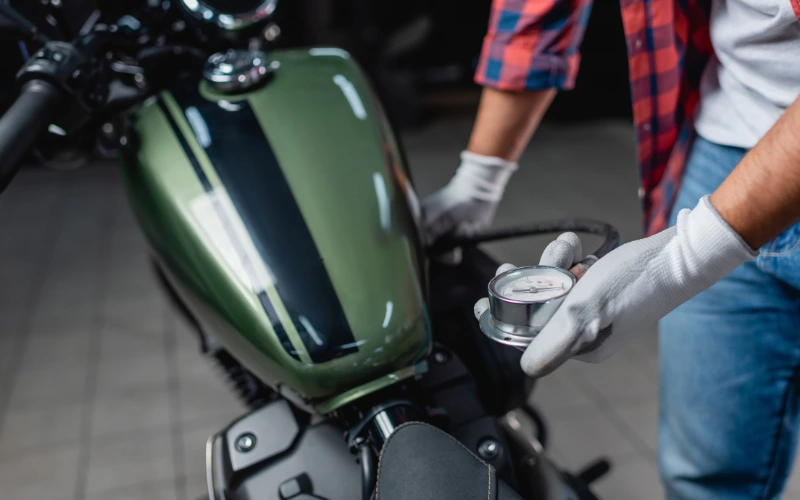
<box><xmin>158</xmin><ymin>97</ymin><xmax>300</xmax><ymax>361</ymax></box>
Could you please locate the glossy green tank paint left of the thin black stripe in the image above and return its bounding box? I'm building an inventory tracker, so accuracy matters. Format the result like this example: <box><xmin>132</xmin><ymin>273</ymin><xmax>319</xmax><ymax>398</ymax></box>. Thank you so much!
<box><xmin>125</xmin><ymin>94</ymin><xmax>310</xmax><ymax>394</ymax></box>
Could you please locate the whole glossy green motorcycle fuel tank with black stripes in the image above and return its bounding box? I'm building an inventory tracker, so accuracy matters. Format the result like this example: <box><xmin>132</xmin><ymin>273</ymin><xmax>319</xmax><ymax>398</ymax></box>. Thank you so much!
<box><xmin>125</xmin><ymin>48</ymin><xmax>431</xmax><ymax>413</ymax></box>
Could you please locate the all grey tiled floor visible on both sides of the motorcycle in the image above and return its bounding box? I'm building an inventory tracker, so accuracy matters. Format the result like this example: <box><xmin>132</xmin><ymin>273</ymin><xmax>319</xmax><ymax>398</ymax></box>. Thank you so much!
<box><xmin>0</xmin><ymin>115</ymin><xmax>800</xmax><ymax>500</ymax></box>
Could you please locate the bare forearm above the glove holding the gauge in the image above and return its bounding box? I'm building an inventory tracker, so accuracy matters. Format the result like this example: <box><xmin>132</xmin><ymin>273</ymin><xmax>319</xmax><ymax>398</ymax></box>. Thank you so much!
<box><xmin>711</xmin><ymin>98</ymin><xmax>800</xmax><ymax>249</ymax></box>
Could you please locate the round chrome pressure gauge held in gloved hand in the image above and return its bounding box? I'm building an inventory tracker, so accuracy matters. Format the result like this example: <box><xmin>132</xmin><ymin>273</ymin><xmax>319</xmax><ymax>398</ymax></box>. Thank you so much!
<box><xmin>480</xmin><ymin>266</ymin><xmax>576</xmax><ymax>349</ymax></box>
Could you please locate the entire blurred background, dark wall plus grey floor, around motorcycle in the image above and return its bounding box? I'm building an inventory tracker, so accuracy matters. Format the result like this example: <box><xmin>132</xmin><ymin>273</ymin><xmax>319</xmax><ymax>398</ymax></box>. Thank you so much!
<box><xmin>0</xmin><ymin>0</ymin><xmax>800</xmax><ymax>500</ymax></box>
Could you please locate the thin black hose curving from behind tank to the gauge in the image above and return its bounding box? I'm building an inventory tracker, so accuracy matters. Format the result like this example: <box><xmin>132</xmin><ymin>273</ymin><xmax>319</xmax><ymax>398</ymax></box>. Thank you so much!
<box><xmin>427</xmin><ymin>219</ymin><xmax>619</xmax><ymax>258</ymax></box>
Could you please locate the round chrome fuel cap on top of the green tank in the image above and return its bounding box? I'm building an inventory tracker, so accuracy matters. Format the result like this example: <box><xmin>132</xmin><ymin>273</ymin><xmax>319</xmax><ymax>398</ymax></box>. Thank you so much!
<box><xmin>203</xmin><ymin>49</ymin><xmax>274</xmax><ymax>94</ymax></box>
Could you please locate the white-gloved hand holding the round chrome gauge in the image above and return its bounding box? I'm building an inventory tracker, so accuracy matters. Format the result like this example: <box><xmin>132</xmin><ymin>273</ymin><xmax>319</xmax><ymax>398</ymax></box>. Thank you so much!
<box><xmin>476</xmin><ymin>196</ymin><xmax>757</xmax><ymax>377</ymax></box>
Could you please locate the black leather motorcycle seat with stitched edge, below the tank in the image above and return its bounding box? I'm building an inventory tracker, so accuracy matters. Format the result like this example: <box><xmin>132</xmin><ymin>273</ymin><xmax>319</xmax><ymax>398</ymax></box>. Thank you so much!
<box><xmin>375</xmin><ymin>422</ymin><xmax>522</xmax><ymax>500</ymax></box>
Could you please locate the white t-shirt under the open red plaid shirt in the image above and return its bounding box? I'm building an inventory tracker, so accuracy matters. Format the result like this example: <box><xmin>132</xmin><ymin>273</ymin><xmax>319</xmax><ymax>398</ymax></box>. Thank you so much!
<box><xmin>695</xmin><ymin>0</ymin><xmax>800</xmax><ymax>148</ymax></box>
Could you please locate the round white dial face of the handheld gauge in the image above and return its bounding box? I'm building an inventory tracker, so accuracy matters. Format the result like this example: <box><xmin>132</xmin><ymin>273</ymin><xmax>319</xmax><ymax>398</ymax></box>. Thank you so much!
<box><xmin>489</xmin><ymin>266</ymin><xmax>575</xmax><ymax>303</ymax></box>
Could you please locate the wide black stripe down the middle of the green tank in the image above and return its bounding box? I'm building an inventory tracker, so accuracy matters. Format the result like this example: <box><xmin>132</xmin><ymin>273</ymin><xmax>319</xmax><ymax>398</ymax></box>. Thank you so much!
<box><xmin>172</xmin><ymin>81</ymin><xmax>358</xmax><ymax>363</ymax></box>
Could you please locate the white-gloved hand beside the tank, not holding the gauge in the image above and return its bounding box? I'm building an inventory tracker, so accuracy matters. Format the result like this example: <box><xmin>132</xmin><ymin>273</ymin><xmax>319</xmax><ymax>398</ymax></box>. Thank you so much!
<box><xmin>422</xmin><ymin>151</ymin><xmax>517</xmax><ymax>252</ymax></box>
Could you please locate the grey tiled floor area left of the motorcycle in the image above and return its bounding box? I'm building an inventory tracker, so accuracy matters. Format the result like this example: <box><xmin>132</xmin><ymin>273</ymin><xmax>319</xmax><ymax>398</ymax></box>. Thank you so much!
<box><xmin>0</xmin><ymin>165</ymin><xmax>242</xmax><ymax>500</ymax></box>
